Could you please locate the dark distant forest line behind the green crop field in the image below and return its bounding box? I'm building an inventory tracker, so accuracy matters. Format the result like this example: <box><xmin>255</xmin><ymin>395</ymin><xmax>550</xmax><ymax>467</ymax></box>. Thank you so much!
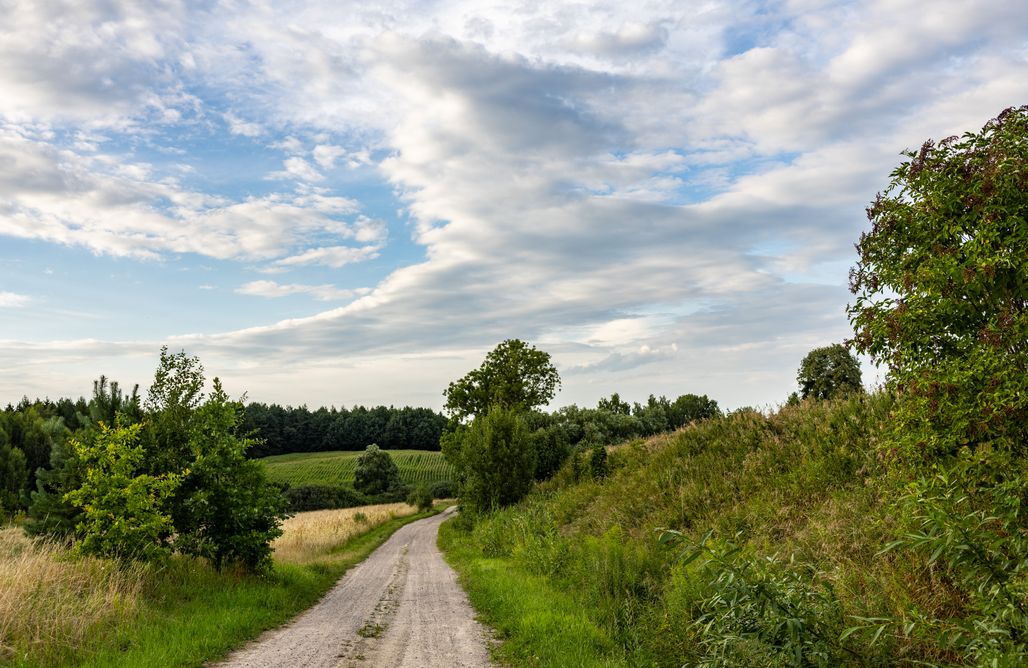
<box><xmin>241</xmin><ymin>403</ymin><xmax>446</xmax><ymax>457</ymax></box>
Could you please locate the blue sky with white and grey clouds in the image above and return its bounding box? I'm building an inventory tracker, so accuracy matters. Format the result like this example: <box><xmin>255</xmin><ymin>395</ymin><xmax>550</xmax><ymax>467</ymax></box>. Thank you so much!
<box><xmin>0</xmin><ymin>0</ymin><xmax>1028</xmax><ymax>408</ymax></box>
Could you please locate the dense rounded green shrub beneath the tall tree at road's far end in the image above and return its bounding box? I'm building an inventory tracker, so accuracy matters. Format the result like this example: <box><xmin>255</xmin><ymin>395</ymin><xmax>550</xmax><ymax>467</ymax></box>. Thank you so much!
<box><xmin>443</xmin><ymin>406</ymin><xmax>536</xmax><ymax>512</ymax></box>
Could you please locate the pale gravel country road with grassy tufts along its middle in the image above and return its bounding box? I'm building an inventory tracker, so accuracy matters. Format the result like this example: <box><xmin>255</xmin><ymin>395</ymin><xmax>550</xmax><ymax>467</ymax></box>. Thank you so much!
<box><xmin>217</xmin><ymin>508</ymin><xmax>489</xmax><ymax>668</ymax></box>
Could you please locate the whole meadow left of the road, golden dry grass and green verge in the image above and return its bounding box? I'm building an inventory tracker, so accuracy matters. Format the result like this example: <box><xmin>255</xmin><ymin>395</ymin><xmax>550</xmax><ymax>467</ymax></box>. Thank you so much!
<box><xmin>0</xmin><ymin>504</ymin><xmax>427</xmax><ymax>667</ymax></box>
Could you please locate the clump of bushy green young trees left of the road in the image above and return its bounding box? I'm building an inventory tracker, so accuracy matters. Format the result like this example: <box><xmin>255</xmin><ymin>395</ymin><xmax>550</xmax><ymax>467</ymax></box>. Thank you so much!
<box><xmin>27</xmin><ymin>348</ymin><xmax>285</xmax><ymax>571</ymax></box>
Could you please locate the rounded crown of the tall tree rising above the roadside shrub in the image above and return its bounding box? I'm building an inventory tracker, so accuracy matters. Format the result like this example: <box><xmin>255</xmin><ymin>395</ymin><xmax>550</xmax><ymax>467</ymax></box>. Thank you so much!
<box><xmin>443</xmin><ymin>339</ymin><xmax>560</xmax><ymax>421</ymax></box>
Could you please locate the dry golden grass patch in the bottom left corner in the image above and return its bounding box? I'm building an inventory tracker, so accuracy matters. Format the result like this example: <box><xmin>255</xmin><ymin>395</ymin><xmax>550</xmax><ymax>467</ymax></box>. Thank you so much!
<box><xmin>0</xmin><ymin>527</ymin><xmax>147</xmax><ymax>662</ymax></box>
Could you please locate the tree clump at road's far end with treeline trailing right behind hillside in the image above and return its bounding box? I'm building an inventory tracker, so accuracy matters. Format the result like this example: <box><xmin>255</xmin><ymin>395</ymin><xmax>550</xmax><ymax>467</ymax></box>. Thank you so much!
<box><xmin>442</xmin><ymin>339</ymin><xmax>721</xmax><ymax>512</ymax></box>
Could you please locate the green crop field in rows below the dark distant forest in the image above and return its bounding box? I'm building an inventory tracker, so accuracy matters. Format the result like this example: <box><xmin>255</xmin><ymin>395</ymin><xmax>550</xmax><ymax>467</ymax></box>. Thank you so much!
<box><xmin>261</xmin><ymin>450</ymin><xmax>453</xmax><ymax>487</ymax></box>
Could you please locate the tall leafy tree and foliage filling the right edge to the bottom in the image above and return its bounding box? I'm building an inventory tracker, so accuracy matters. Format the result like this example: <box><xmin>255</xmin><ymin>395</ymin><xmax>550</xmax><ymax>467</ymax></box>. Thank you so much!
<box><xmin>849</xmin><ymin>106</ymin><xmax>1028</xmax><ymax>665</ymax></box>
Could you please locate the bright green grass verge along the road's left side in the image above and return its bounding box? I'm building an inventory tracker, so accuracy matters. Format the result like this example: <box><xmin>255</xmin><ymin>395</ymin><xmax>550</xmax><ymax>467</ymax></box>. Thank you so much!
<box><xmin>9</xmin><ymin>510</ymin><xmax>438</xmax><ymax>668</ymax></box>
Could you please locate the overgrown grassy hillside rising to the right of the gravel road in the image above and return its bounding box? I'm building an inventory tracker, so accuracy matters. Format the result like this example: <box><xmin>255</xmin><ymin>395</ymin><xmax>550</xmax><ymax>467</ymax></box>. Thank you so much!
<box><xmin>441</xmin><ymin>395</ymin><xmax>1011</xmax><ymax>666</ymax></box>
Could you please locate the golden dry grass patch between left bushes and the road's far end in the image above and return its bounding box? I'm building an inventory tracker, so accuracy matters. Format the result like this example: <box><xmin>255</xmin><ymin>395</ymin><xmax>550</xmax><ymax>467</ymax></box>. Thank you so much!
<box><xmin>271</xmin><ymin>504</ymin><xmax>417</xmax><ymax>564</ymax></box>
